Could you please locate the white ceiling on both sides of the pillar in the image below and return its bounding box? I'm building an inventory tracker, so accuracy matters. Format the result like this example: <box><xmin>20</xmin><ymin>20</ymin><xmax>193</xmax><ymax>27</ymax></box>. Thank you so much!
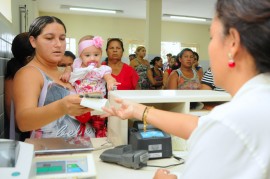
<box><xmin>36</xmin><ymin>0</ymin><xmax>216</xmax><ymax>24</ymax></box>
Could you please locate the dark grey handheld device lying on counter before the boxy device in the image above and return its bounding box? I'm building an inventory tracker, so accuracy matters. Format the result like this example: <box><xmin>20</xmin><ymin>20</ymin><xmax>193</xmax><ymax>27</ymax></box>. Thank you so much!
<box><xmin>99</xmin><ymin>145</ymin><xmax>148</xmax><ymax>169</ymax></box>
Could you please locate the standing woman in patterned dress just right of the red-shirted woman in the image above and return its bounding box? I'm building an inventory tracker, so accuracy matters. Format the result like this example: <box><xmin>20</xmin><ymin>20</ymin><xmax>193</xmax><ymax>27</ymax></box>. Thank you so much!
<box><xmin>130</xmin><ymin>46</ymin><xmax>150</xmax><ymax>90</ymax></box>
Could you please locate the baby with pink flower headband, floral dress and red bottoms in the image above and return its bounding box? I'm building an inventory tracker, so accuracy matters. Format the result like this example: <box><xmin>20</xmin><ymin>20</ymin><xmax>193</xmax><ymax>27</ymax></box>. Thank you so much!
<box><xmin>61</xmin><ymin>36</ymin><xmax>119</xmax><ymax>137</ymax></box>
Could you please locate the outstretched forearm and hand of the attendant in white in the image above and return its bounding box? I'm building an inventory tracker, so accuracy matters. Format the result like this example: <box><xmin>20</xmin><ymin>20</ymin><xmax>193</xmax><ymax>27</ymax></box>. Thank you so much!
<box><xmin>103</xmin><ymin>99</ymin><xmax>198</xmax><ymax>139</ymax></box>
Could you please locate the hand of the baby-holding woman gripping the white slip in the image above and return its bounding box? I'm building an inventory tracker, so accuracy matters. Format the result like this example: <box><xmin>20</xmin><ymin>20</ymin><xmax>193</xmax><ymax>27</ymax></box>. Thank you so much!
<box><xmin>60</xmin><ymin>94</ymin><xmax>92</xmax><ymax>116</ymax></box>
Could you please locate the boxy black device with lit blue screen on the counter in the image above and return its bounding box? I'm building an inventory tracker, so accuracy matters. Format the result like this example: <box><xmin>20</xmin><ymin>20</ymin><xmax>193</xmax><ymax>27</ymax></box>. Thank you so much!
<box><xmin>128</xmin><ymin>121</ymin><xmax>172</xmax><ymax>159</ymax></box>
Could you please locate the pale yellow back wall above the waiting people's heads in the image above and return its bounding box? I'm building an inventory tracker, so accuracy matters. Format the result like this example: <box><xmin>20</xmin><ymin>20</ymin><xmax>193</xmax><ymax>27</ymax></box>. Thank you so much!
<box><xmin>40</xmin><ymin>12</ymin><xmax>210</xmax><ymax>67</ymax></box>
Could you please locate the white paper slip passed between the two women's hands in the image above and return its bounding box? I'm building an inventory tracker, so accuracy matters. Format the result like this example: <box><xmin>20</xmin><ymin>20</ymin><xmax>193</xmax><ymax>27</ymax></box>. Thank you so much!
<box><xmin>81</xmin><ymin>98</ymin><xmax>109</xmax><ymax>112</ymax></box>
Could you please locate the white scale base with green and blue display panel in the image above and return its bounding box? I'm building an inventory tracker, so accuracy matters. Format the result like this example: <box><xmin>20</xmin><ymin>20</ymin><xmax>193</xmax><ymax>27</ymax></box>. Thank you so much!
<box><xmin>34</xmin><ymin>153</ymin><xmax>96</xmax><ymax>179</ymax></box>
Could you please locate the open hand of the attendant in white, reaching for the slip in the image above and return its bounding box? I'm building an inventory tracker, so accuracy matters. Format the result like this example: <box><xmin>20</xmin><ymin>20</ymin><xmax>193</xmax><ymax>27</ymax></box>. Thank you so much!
<box><xmin>101</xmin><ymin>99</ymin><xmax>145</xmax><ymax>119</ymax></box>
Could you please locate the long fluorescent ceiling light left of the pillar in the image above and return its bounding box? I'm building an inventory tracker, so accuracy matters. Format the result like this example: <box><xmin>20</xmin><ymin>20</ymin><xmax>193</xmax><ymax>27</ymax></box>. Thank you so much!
<box><xmin>61</xmin><ymin>5</ymin><xmax>123</xmax><ymax>14</ymax></box>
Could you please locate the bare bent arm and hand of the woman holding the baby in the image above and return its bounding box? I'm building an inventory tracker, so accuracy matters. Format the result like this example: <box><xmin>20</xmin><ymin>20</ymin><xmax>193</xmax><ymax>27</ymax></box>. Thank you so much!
<box><xmin>13</xmin><ymin>66</ymin><xmax>90</xmax><ymax>132</ymax></box>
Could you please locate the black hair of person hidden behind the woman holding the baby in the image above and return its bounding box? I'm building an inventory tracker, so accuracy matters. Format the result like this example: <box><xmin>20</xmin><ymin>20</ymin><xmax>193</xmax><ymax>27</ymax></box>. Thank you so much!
<box><xmin>5</xmin><ymin>32</ymin><xmax>34</xmax><ymax>79</ymax></box>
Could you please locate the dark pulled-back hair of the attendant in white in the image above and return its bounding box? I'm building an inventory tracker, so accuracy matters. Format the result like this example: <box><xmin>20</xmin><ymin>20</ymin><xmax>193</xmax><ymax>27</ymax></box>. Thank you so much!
<box><xmin>216</xmin><ymin>0</ymin><xmax>270</xmax><ymax>73</ymax></box>
